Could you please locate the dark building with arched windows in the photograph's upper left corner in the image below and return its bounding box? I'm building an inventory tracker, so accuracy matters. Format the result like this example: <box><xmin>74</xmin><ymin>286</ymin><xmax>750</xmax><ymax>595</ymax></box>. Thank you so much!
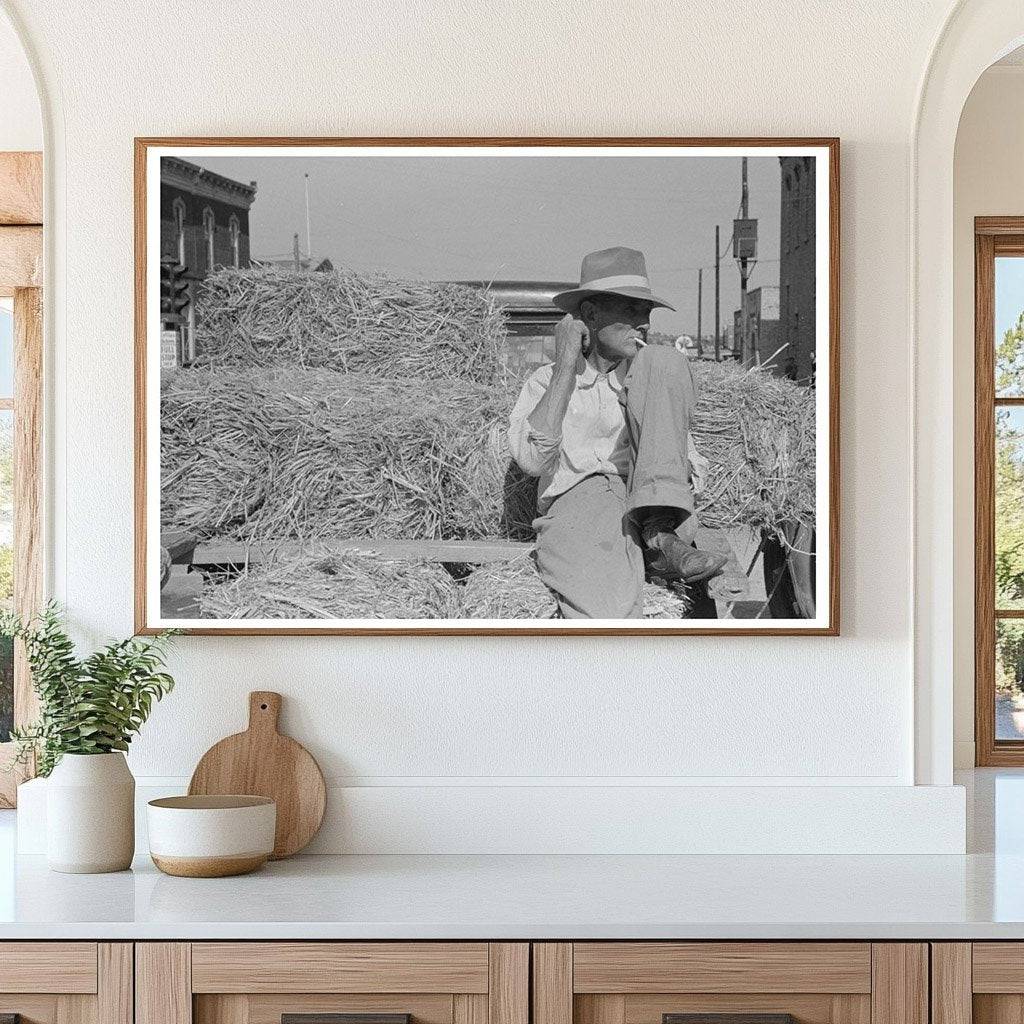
<box><xmin>160</xmin><ymin>157</ymin><xmax>256</xmax><ymax>357</ymax></box>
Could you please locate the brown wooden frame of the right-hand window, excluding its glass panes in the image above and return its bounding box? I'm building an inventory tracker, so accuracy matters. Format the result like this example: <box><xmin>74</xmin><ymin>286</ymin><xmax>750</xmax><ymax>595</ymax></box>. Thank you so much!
<box><xmin>974</xmin><ymin>216</ymin><xmax>1024</xmax><ymax>768</ymax></box>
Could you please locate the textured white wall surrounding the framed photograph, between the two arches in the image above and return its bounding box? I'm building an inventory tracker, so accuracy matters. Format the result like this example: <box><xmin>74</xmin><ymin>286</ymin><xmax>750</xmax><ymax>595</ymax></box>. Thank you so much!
<box><xmin>0</xmin><ymin>0</ymin><xmax>974</xmax><ymax>847</ymax></box>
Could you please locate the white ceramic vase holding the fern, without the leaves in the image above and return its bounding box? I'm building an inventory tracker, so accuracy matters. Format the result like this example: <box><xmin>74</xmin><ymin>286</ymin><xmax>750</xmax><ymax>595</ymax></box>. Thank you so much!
<box><xmin>46</xmin><ymin>753</ymin><xmax>135</xmax><ymax>874</ymax></box>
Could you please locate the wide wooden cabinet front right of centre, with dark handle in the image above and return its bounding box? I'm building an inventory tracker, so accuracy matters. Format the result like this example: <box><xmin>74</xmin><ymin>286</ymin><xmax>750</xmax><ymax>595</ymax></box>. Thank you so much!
<box><xmin>534</xmin><ymin>942</ymin><xmax>928</xmax><ymax>1024</ymax></box>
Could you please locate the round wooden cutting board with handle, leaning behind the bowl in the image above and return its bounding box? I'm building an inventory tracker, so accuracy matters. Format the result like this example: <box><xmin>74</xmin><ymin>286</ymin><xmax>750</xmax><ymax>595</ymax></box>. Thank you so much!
<box><xmin>188</xmin><ymin>690</ymin><xmax>327</xmax><ymax>860</ymax></box>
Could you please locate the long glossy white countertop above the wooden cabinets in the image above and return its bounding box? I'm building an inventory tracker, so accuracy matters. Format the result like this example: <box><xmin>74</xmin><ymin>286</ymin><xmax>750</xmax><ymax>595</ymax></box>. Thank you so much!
<box><xmin>0</xmin><ymin>855</ymin><xmax>1024</xmax><ymax>939</ymax></box>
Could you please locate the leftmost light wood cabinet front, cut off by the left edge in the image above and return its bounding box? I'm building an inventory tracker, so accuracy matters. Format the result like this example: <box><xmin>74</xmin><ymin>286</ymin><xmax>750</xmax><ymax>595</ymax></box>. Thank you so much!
<box><xmin>0</xmin><ymin>942</ymin><xmax>132</xmax><ymax>1024</ymax></box>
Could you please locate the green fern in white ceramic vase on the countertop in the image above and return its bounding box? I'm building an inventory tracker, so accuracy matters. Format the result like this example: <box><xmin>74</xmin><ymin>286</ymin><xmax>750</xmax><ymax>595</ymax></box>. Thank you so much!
<box><xmin>0</xmin><ymin>603</ymin><xmax>174</xmax><ymax>873</ymax></box>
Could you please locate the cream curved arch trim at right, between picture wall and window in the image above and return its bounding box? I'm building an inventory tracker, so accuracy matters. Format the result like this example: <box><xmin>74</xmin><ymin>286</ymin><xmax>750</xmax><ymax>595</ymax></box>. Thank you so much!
<box><xmin>908</xmin><ymin>0</ymin><xmax>1024</xmax><ymax>785</ymax></box>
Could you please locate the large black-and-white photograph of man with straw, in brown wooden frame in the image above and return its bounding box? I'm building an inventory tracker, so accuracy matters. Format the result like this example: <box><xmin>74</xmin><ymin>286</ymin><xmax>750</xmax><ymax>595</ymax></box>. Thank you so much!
<box><xmin>135</xmin><ymin>138</ymin><xmax>839</xmax><ymax>635</ymax></box>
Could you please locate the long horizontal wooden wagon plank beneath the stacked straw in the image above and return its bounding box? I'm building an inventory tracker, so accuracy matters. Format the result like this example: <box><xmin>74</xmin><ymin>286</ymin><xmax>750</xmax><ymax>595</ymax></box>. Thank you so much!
<box><xmin>191</xmin><ymin>540</ymin><xmax>534</xmax><ymax>568</ymax></box>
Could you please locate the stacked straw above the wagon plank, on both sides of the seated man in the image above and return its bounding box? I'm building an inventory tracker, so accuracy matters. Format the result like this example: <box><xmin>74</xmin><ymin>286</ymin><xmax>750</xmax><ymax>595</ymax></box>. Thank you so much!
<box><xmin>172</xmin><ymin>267</ymin><xmax>815</xmax><ymax>541</ymax></box>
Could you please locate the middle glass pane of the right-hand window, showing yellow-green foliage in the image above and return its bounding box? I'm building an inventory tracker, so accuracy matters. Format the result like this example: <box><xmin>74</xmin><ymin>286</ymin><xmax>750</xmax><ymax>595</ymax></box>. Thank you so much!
<box><xmin>995</xmin><ymin>407</ymin><xmax>1024</xmax><ymax>608</ymax></box>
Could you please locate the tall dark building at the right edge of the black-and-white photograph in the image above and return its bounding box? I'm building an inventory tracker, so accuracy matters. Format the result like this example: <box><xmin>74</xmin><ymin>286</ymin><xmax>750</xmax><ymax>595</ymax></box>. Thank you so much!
<box><xmin>778</xmin><ymin>157</ymin><xmax>816</xmax><ymax>382</ymax></box>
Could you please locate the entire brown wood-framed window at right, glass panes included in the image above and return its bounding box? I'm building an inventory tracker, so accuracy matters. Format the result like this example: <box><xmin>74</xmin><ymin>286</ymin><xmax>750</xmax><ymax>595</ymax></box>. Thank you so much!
<box><xmin>975</xmin><ymin>217</ymin><xmax>1024</xmax><ymax>766</ymax></box>
